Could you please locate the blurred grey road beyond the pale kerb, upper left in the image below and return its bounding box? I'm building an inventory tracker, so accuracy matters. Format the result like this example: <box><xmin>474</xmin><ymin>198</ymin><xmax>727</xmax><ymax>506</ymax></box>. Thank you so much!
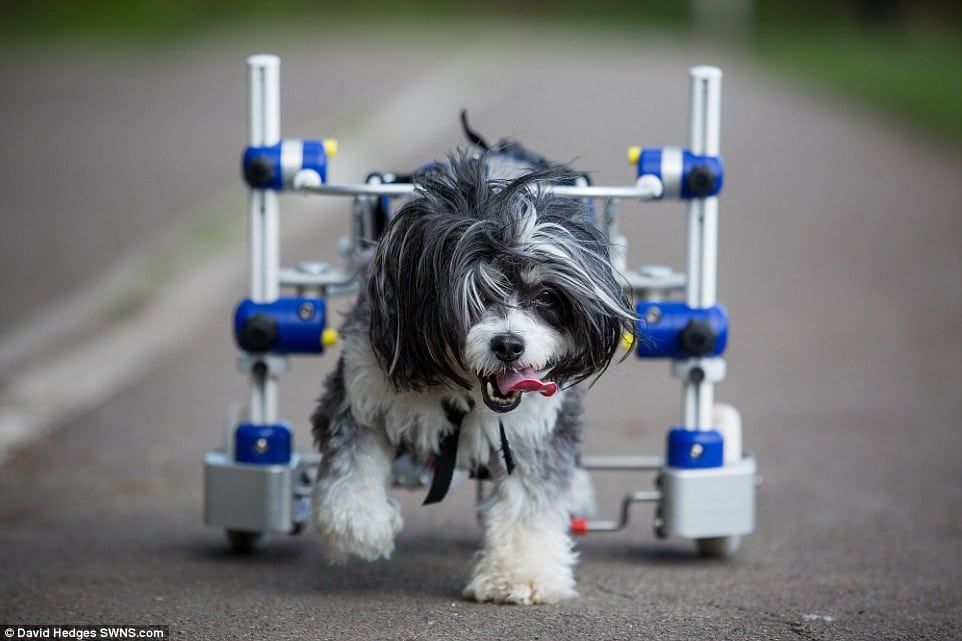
<box><xmin>0</xmin><ymin>34</ymin><xmax>451</xmax><ymax>350</ymax></box>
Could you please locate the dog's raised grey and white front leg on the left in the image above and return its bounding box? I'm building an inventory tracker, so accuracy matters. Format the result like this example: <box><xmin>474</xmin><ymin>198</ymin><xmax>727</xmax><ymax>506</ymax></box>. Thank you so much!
<box><xmin>312</xmin><ymin>363</ymin><xmax>402</xmax><ymax>562</ymax></box>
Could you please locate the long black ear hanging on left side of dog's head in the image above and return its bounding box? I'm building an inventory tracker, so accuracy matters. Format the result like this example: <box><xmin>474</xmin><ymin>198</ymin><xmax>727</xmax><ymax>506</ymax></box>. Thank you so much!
<box><xmin>367</xmin><ymin>199</ymin><xmax>471</xmax><ymax>391</ymax></box>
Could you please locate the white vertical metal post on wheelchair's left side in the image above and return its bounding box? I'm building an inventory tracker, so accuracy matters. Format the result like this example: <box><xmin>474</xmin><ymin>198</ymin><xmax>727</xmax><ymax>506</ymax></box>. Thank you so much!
<box><xmin>247</xmin><ymin>54</ymin><xmax>281</xmax><ymax>424</ymax></box>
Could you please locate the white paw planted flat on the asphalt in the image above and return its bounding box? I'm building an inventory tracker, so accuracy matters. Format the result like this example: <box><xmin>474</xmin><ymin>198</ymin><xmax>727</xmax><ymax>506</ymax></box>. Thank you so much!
<box><xmin>464</xmin><ymin>559</ymin><xmax>578</xmax><ymax>605</ymax></box>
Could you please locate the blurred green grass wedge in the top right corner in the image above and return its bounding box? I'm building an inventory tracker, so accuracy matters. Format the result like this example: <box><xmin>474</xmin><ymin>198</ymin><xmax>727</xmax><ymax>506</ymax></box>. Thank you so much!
<box><xmin>748</xmin><ymin>0</ymin><xmax>962</xmax><ymax>143</ymax></box>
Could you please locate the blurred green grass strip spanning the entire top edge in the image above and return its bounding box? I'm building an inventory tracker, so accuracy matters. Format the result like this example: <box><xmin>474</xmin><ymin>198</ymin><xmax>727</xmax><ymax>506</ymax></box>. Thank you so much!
<box><xmin>0</xmin><ymin>0</ymin><xmax>962</xmax><ymax>142</ymax></box>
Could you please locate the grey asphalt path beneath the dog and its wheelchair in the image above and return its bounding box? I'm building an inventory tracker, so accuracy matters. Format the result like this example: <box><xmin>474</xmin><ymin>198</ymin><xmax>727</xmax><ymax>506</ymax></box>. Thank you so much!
<box><xmin>0</xmin><ymin>27</ymin><xmax>962</xmax><ymax>639</ymax></box>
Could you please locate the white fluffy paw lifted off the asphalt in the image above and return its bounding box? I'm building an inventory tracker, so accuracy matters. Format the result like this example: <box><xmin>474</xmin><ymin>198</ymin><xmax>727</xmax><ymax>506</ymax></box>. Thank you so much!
<box><xmin>313</xmin><ymin>486</ymin><xmax>404</xmax><ymax>563</ymax></box>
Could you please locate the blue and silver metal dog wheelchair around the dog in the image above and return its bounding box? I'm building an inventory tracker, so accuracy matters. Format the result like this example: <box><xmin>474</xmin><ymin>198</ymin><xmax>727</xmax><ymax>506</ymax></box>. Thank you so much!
<box><xmin>204</xmin><ymin>55</ymin><xmax>757</xmax><ymax>556</ymax></box>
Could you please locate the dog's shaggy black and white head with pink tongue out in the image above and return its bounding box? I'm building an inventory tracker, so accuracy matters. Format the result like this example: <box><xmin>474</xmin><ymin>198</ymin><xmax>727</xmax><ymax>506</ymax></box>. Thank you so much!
<box><xmin>368</xmin><ymin>155</ymin><xmax>634</xmax><ymax>412</ymax></box>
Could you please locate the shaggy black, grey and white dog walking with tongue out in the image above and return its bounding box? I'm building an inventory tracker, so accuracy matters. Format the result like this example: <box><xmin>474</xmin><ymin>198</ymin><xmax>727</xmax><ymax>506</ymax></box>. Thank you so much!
<box><xmin>313</xmin><ymin>142</ymin><xmax>634</xmax><ymax>604</ymax></box>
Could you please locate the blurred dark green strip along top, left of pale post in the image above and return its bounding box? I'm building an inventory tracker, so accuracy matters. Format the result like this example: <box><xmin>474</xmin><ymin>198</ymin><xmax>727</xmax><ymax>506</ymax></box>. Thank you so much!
<box><xmin>0</xmin><ymin>0</ymin><xmax>691</xmax><ymax>42</ymax></box>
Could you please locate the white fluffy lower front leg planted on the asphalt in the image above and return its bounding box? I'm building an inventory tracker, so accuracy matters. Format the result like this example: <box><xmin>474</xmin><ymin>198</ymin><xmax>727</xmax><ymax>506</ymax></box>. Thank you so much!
<box><xmin>464</xmin><ymin>465</ymin><xmax>577</xmax><ymax>605</ymax></box>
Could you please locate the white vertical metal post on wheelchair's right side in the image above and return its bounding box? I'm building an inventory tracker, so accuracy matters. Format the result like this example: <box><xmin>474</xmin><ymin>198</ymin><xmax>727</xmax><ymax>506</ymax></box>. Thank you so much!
<box><xmin>682</xmin><ymin>66</ymin><xmax>722</xmax><ymax>429</ymax></box>
